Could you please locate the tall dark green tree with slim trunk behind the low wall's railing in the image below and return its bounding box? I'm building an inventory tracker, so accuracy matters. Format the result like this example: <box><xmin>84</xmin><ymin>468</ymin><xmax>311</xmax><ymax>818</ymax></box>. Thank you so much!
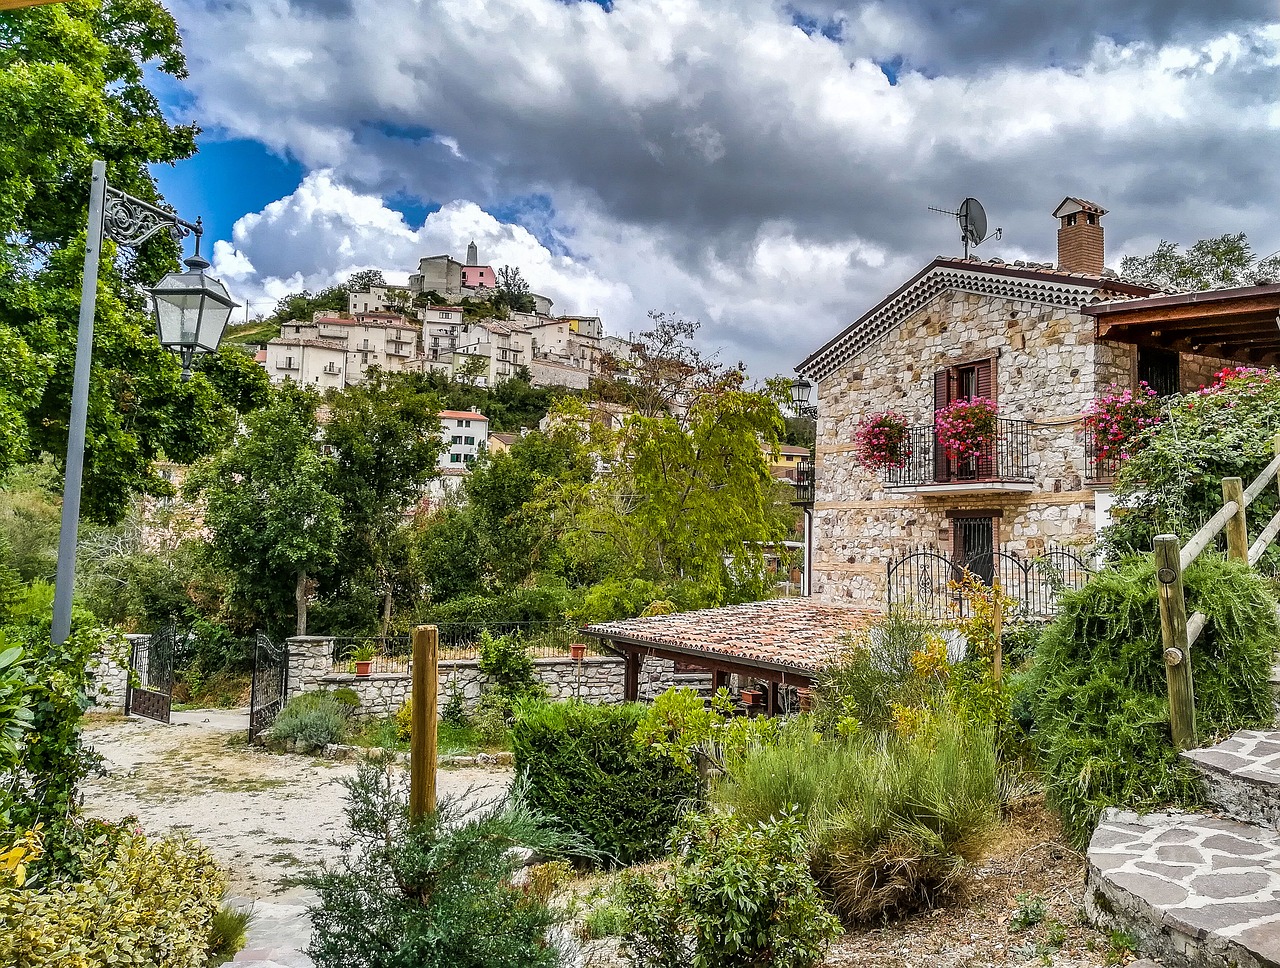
<box><xmin>324</xmin><ymin>369</ymin><xmax>444</xmax><ymax>634</ymax></box>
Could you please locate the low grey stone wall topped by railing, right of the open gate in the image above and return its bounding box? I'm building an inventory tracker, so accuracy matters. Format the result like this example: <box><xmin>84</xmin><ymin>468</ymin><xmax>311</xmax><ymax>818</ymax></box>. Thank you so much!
<box><xmin>288</xmin><ymin>636</ymin><xmax>676</xmax><ymax>716</ymax></box>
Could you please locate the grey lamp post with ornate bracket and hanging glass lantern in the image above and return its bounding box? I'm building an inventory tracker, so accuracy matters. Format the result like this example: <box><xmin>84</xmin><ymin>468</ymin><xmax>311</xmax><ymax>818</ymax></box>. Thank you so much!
<box><xmin>50</xmin><ymin>161</ymin><xmax>237</xmax><ymax>645</ymax></box>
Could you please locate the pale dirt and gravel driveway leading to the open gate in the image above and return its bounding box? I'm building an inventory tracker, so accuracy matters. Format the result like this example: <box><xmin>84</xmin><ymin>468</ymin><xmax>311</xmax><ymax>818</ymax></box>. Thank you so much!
<box><xmin>77</xmin><ymin>711</ymin><xmax>511</xmax><ymax>901</ymax></box>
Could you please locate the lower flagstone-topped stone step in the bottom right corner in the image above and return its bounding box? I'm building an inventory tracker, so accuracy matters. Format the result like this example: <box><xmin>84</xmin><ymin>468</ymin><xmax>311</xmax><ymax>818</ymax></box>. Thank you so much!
<box><xmin>1084</xmin><ymin>809</ymin><xmax>1280</xmax><ymax>968</ymax></box>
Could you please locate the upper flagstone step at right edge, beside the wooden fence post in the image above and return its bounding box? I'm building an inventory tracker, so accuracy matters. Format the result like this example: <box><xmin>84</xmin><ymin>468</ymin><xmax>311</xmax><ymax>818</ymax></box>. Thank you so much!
<box><xmin>1181</xmin><ymin>730</ymin><xmax>1280</xmax><ymax>828</ymax></box>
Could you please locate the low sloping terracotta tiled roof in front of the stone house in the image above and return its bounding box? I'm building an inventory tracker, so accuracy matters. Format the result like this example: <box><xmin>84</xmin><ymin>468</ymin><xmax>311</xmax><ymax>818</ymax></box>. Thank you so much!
<box><xmin>584</xmin><ymin>598</ymin><xmax>876</xmax><ymax>682</ymax></box>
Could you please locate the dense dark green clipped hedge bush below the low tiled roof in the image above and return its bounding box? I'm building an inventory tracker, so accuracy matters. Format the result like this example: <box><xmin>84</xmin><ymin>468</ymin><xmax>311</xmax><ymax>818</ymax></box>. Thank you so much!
<box><xmin>512</xmin><ymin>700</ymin><xmax>698</xmax><ymax>864</ymax></box>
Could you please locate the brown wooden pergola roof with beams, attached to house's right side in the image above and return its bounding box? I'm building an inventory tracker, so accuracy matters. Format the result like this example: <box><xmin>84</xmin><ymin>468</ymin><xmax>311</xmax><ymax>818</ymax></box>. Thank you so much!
<box><xmin>1080</xmin><ymin>284</ymin><xmax>1280</xmax><ymax>366</ymax></box>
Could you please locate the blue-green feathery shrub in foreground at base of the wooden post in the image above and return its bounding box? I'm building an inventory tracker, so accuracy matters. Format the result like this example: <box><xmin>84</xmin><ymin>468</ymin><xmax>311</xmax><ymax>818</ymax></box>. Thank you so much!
<box><xmin>301</xmin><ymin>761</ymin><xmax>584</xmax><ymax>968</ymax></box>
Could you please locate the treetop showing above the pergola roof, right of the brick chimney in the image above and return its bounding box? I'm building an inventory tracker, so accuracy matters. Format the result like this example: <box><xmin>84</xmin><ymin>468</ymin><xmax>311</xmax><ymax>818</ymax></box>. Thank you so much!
<box><xmin>1120</xmin><ymin>232</ymin><xmax>1280</xmax><ymax>291</ymax></box>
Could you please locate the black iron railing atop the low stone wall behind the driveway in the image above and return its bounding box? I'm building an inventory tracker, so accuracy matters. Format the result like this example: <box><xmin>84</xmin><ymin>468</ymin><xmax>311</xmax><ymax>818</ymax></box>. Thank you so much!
<box><xmin>325</xmin><ymin>622</ymin><xmax>600</xmax><ymax>674</ymax></box>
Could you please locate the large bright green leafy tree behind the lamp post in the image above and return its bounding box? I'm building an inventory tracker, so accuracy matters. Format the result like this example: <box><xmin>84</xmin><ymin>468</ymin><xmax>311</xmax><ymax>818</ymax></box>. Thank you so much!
<box><xmin>0</xmin><ymin>0</ymin><xmax>259</xmax><ymax>521</ymax></box>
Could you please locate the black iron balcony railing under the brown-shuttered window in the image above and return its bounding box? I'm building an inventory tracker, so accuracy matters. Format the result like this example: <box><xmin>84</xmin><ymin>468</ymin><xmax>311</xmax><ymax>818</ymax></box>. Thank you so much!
<box><xmin>884</xmin><ymin>417</ymin><xmax>1033</xmax><ymax>487</ymax></box>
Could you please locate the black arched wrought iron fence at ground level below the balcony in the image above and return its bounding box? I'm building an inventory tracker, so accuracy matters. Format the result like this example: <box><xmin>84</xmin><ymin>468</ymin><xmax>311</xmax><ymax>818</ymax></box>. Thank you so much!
<box><xmin>887</xmin><ymin>548</ymin><xmax>1093</xmax><ymax>620</ymax></box>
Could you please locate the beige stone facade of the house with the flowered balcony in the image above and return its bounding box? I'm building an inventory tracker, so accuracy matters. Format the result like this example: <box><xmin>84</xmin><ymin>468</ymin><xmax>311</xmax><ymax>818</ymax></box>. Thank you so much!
<box><xmin>813</xmin><ymin>264</ymin><xmax>1222</xmax><ymax>608</ymax></box>
